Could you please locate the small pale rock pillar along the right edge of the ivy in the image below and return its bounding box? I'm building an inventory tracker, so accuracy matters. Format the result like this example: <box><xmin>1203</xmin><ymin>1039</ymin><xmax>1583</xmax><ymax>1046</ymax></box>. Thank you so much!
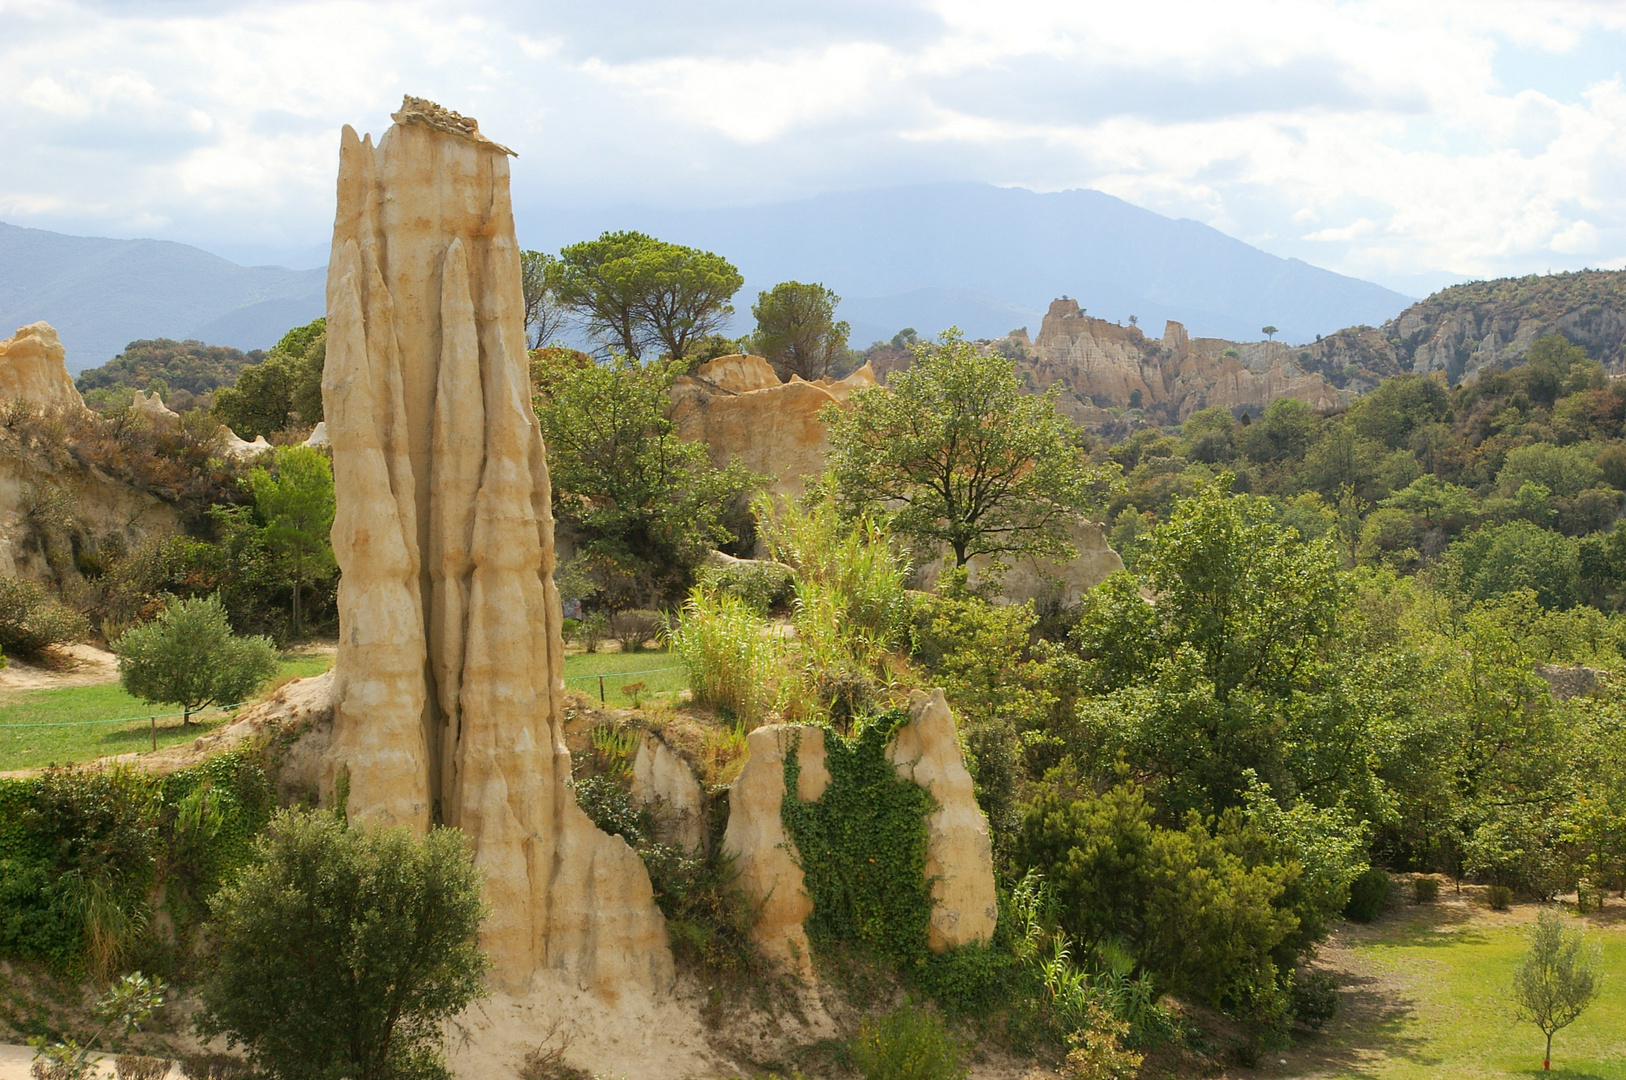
<box><xmin>886</xmin><ymin>690</ymin><xmax>1000</xmax><ymax>952</ymax></box>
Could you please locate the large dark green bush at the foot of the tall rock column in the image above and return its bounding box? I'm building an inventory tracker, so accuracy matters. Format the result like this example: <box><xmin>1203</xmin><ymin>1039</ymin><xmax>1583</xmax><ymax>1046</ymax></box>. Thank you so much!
<box><xmin>198</xmin><ymin>810</ymin><xmax>488</xmax><ymax>1080</ymax></box>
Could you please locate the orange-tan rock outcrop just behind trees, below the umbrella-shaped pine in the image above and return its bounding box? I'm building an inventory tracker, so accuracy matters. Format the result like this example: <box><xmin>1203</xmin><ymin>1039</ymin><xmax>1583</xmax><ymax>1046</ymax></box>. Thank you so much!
<box><xmin>672</xmin><ymin>356</ymin><xmax>875</xmax><ymax>496</ymax></box>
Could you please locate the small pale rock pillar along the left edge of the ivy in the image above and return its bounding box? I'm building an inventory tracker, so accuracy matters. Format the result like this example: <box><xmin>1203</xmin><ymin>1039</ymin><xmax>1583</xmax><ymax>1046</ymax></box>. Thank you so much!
<box><xmin>722</xmin><ymin>724</ymin><xmax>829</xmax><ymax>981</ymax></box>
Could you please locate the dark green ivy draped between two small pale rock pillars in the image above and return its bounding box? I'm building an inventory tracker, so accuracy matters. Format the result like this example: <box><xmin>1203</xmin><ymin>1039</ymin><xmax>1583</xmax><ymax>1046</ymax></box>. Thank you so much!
<box><xmin>780</xmin><ymin>709</ymin><xmax>932</xmax><ymax>969</ymax></box>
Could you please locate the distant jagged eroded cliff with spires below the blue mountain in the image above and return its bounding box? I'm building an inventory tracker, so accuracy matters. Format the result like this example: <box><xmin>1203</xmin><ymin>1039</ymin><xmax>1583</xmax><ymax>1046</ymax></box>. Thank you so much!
<box><xmin>1015</xmin><ymin>299</ymin><xmax>1353</xmax><ymax>425</ymax></box>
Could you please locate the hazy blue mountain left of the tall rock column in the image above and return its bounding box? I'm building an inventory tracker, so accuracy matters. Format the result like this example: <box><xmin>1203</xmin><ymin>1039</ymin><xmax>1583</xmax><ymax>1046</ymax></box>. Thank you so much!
<box><xmin>0</xmin><ymin>223</ymin><xmax>327</xmax><ymax>372</ymax></box>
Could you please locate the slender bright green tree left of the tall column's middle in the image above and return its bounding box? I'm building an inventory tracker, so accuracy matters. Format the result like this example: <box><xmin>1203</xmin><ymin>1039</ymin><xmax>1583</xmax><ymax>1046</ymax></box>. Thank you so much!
<box><xmin>249</xmin><ymin>446</ymin><xmax>338</xmax><ymax>636</ymax></box>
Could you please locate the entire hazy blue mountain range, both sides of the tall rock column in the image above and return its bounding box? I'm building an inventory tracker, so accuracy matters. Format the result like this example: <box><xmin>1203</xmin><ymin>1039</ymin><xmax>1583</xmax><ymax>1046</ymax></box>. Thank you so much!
<box><xmin>0</xmin><ymin>184</ymin><xmax>1411</xmax><ymax>371</ymax></box>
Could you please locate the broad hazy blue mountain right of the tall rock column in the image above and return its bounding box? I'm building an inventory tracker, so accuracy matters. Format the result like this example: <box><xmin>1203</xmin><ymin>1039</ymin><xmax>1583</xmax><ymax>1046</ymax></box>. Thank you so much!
<box><xmin>517</xmin><ymin>184</ymin><xmax>1413</xmax><ymax>345</ymax></box>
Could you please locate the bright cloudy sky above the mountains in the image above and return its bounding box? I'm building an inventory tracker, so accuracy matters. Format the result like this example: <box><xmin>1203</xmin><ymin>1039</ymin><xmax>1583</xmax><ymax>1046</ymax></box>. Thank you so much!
<box><xmin>0</xmin><ymin>0</ymin><xmax>1626</xmax><ymax>293</ymax></box>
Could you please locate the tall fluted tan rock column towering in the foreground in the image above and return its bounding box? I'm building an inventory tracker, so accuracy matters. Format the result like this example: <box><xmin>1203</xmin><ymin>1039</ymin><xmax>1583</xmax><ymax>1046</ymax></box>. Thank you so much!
<box><xmin>322</xmin><ymin>98</ymin><xmax>673</xmax><ymax>994</ymax></box>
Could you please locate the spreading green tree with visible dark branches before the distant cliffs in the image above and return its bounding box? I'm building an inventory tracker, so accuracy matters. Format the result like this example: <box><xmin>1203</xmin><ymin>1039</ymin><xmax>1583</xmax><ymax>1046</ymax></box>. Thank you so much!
<box><xmin>821</xmin><ymin>330</ymin><xmax>1114</xmax><ymax>566</ymax></box>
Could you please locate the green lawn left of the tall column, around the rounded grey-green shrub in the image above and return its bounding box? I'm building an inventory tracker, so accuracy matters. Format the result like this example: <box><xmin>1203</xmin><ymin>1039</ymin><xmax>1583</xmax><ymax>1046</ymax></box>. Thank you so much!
<box><xmin>0</xmin><ymin>654</ymin><xmax>332</xmax><ymax>771</ymax></box>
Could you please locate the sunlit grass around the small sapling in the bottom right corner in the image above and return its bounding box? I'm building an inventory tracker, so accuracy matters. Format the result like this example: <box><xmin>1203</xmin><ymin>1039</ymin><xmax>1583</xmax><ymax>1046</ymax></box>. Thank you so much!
<box><xmin>1259</xmin><ymin>898</ymin><xmax>1626</xmax><ymax>1080</ymax></box>
